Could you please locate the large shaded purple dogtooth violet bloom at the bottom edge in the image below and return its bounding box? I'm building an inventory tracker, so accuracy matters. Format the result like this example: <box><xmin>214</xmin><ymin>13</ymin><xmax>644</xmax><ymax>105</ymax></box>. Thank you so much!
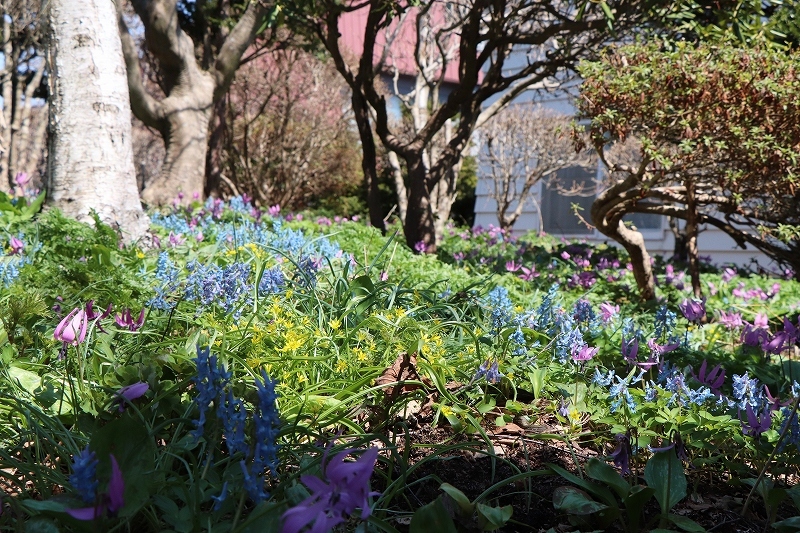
<box><xmin>281</xmin><ymin>448</ymin><xmax>378</xmax><ymax>533</ymax></box>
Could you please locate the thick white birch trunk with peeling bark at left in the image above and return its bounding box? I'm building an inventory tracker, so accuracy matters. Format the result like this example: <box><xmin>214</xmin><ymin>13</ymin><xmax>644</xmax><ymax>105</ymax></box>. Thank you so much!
<box><xmin>46</xmin><ymin>0</ymin><xmax>149</xmax><ymax>242</ymax></box>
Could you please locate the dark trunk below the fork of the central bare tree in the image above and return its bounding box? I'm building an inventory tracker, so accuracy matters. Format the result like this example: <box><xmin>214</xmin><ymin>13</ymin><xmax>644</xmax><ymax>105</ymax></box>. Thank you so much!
<box><xmin>404</xmin><ymin>157</ymin><xmax>436</xmax><ymax>253</ymax></box>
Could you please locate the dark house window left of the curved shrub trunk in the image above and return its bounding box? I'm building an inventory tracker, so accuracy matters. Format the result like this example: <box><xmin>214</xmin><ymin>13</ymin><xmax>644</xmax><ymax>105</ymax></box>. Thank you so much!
<box><xmin>541</xmin><ymin>167</ymin><xmax>595</xmax><ymax>235</ymax></box>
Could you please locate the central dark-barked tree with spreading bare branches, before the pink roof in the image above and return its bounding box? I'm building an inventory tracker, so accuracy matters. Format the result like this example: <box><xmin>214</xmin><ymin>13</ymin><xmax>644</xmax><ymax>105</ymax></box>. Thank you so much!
<box><xmin>290</xmin><ymin>0</ymin><xmax>644</xmax><ymax>251</ymax></box>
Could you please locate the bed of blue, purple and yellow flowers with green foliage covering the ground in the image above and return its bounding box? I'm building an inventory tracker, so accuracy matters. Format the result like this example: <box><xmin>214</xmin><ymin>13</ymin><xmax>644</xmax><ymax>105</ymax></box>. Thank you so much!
<box><xmin>0</xmin><ymin>193</ymin><xmax>800</xmax><ymax>532</ymax></box>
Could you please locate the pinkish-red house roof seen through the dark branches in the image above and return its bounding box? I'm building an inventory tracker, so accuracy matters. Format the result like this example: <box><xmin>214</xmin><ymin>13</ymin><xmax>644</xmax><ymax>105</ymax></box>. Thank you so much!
<box><xmin>339</xmin><ymin>4</ymin><xmax>459</xmax><ymax>83</ymax></box>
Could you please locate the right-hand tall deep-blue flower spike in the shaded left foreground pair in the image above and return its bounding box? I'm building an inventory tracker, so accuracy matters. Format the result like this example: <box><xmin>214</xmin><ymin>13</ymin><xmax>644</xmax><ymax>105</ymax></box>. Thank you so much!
<box><xmin>241</xmin><ymin>370</ymin><xmax>280</xmax><ymax>502</ymax></box>
